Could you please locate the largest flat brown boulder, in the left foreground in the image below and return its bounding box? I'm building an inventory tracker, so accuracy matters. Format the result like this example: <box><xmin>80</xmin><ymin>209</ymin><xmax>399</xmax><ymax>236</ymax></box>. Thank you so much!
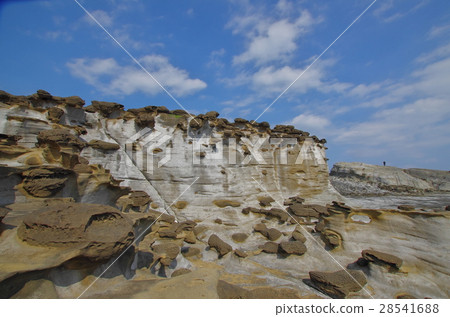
<box><xmin>17</xmin><ymin>203</ymin><xmax>134</xmax><ymax>261</ymax></box>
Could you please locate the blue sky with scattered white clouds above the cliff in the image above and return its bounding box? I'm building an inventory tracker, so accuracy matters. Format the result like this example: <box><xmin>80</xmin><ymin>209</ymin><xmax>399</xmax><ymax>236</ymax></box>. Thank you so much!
<box><xmin>0</xmin><ymin>0</ymin><xmax>450</xmax><ymax>170</ymax></box>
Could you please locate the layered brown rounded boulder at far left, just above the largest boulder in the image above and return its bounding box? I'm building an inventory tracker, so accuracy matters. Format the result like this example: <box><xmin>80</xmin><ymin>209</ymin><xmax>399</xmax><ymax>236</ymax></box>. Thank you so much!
<box><xmin>22</xmin><ymin>166</ymin><xmax>73</xmax><ymax>198</ymax></box>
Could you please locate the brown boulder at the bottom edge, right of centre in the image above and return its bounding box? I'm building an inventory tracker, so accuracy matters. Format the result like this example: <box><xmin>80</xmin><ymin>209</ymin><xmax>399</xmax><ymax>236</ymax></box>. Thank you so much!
<box><xmin>309</xmin><ymin>270</ymin><xmax>367</xmax><ymax>298</ymax></box>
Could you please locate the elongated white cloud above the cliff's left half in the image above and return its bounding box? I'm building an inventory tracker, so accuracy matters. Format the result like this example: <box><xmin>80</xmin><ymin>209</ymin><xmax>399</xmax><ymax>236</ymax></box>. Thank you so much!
<box><xmin>67</xmin><ymin>55</ymin><xmax>207</xmax><ymax>96</ymax></box>
